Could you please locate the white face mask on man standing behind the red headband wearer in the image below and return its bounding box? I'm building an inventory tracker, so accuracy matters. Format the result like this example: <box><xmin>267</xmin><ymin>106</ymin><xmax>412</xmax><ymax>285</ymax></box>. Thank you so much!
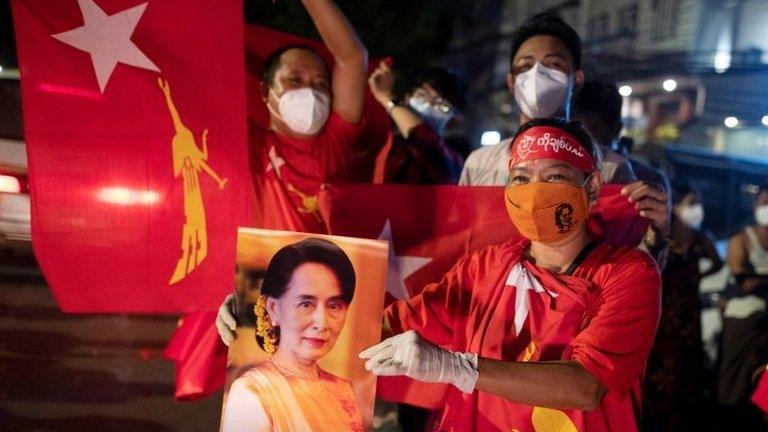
<box><xmin>515</xmin><ymin>63</ymin><xmax>571</xmax><ymax>119</ymax></box>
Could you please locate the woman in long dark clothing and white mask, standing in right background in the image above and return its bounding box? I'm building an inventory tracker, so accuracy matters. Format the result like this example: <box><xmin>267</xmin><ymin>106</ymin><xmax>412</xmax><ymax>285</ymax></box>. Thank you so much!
<box><xmin>643</xmin><ymin>183</ymin><xmax>723</xmax><ymax>432</ymax></box>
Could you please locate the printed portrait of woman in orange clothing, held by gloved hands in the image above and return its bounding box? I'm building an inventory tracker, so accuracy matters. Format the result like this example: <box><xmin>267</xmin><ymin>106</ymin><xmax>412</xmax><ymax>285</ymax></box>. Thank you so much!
<box><xmin>221</xmin><ymin>228</ymin><xmax>388</xmax><ymax>432</ymax></box>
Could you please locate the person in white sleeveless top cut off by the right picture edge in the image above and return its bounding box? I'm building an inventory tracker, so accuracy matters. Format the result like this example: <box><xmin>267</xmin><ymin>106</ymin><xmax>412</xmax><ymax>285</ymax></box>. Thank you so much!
<box><xmin>717</xmin><ymin>183</ymin><xmax>768</xmax><ymax>431</ymax></box>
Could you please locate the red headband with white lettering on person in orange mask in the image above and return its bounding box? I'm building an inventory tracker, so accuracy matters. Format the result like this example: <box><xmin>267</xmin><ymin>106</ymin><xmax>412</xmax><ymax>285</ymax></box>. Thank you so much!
<box><xmin>509</xmin><ymin>126</ymin><xmax>595</xmax><ymax>172</ymax></box>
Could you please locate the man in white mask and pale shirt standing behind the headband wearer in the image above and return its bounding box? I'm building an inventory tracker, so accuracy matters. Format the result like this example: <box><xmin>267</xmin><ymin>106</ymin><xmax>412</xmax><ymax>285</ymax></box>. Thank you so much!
<box><xmin>459</xmin><ymin>13</ymin><xmax>670</xmax><ymax>266</ymax></box>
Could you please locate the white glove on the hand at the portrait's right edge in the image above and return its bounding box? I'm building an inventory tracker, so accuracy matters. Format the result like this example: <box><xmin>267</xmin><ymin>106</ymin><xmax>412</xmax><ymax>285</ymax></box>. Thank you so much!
<box><xmin>360</xmin><ymin>330</ymin><xmax>477</xmax><ymax>393</ymax></box>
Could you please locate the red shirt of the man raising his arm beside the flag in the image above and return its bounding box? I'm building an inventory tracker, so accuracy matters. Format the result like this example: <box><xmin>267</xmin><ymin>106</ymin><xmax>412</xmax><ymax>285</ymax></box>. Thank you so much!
<box><xmin>250</xmin><ymin>112</ymin><xmax>363</xmax><ymax>233</ymax></box>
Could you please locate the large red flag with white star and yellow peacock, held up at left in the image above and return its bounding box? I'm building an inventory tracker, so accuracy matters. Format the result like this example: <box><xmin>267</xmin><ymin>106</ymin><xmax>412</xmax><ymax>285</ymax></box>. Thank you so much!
<box><xmin>13</xmin><ymin>0</ymin><xmax>251</xmax><ymax>312</ymax></box>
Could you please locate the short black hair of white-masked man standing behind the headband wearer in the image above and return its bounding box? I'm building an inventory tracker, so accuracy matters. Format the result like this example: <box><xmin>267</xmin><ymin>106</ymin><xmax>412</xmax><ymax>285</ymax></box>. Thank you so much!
<box><xmin>509</xmin><ymin>13</ymin><xmax>581</xmax><ymax>70</ymax></box>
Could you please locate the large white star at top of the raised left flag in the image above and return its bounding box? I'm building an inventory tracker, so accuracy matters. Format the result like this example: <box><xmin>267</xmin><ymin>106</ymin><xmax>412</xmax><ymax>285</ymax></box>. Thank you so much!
<box><xmin>51</xmin><ymin>0</ymin><xmax>160</xmax><ymax>93</ymax></box>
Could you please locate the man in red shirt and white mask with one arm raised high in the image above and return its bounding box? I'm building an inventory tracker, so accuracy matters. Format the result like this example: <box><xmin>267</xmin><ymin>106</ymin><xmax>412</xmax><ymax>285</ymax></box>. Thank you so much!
<box><xmin>250</xmin><ymin>0</ymin><xmax>367</xmax><ymax>232</ymax></box>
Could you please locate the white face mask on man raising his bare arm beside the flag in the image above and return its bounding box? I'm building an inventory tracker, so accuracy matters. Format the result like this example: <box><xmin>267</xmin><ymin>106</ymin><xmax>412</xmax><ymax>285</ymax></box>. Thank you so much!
<box><xmin>267</xmin><ymin>87</ymin><xmax>331</xmax><ymax>135</ymax></box>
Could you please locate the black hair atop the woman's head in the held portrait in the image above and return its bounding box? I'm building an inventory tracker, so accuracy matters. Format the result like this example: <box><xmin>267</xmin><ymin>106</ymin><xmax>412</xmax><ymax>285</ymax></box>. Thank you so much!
<box><xmin>261</xmin><ymin>238</ymin><xmax>355</xmax><ymax>303</ymax></box>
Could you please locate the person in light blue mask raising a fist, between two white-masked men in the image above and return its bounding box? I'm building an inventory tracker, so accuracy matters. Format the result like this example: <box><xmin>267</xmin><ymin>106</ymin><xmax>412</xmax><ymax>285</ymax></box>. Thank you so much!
<box><xmin>368</xmin><ymin>60</ymin><xmax>467</xmax><ymax>184</ymax></box>
